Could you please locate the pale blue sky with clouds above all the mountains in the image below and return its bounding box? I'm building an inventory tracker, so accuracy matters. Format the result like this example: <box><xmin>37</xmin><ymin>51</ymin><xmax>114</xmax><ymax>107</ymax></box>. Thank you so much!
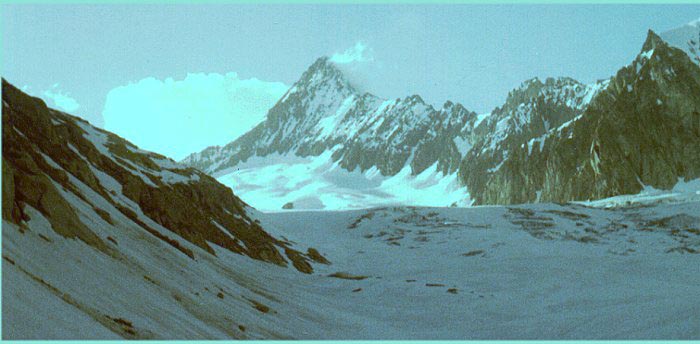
<box><xmin>0</xmin><ymin>4</ymin><xmax>700</xmax><ymax>160</ymax></box>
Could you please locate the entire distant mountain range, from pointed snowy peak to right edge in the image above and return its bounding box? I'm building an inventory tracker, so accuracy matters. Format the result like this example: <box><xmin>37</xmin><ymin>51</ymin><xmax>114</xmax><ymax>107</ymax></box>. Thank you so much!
<box><xmin>182</xmin><ymin>23</ymin><xmax>700</xmax><ymax>209</ymax></box>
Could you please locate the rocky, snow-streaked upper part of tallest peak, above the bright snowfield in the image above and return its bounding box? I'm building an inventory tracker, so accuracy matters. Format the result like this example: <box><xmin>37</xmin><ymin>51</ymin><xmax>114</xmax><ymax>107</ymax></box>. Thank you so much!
<box><xmin>183</xmin><ymin>57</ymin><xmax>477</xmax><ymax>176</ymax></box>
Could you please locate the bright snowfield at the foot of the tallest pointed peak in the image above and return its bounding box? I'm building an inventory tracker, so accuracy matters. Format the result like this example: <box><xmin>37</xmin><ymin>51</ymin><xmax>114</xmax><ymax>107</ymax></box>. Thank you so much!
<box><xmin>217</xmin><ymin>152</ymin><xmax>471</xmax><ymax>211</ymax></box>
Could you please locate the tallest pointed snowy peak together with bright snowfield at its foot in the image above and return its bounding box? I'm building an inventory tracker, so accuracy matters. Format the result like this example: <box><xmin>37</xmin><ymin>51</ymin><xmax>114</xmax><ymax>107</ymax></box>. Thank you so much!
<box><xmin>183</xmin><ymin>57</ymin><xmax>479</xmax><ymax>209</ymax></box>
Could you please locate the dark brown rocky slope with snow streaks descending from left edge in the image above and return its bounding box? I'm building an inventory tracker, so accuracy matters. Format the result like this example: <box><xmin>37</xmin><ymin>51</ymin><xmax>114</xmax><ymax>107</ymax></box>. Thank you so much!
<box><xmin>2</xmin><ymin>80</ymin><xmax>312</xmax><ymax>272</ymax></box>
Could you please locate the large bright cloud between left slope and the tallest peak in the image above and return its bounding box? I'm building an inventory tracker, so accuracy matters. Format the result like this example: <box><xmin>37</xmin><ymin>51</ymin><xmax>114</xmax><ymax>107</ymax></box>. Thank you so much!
<box><xmin>102</xmin><ymin>73</ymin><xmax>289</xmax><ymax>160</ymax></box>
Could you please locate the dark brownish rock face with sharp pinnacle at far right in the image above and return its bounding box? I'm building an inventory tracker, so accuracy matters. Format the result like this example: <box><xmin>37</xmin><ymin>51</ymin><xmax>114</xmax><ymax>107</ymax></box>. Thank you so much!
<box><xmin>460</xmin><ymin>32</ymin><xmax>700</xmax><ymax>204</ymax></box>
